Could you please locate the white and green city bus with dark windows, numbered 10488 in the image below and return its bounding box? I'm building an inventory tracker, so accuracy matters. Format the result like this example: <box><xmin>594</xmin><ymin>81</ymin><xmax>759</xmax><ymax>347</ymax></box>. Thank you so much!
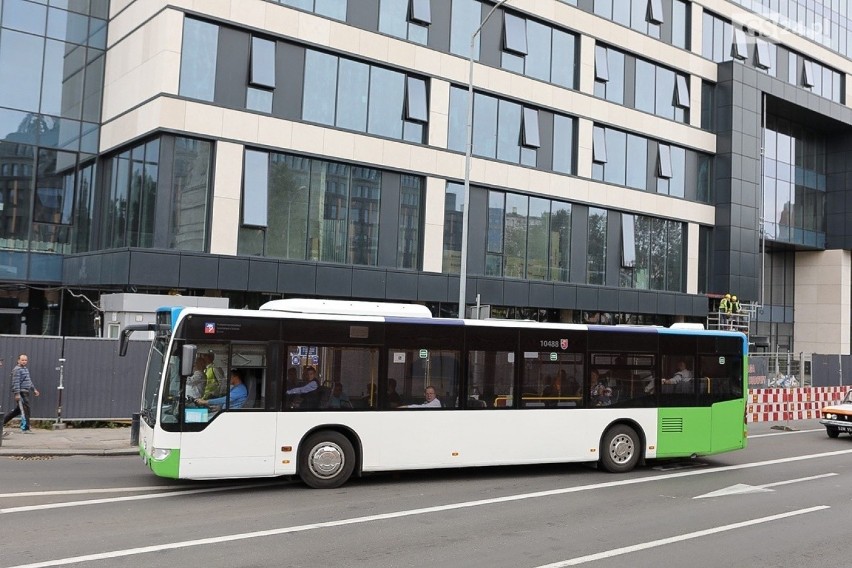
<box><xmin>121</xmin><ymin>299</ymin><xmax>748</xmax><ymax>488</ymax></box>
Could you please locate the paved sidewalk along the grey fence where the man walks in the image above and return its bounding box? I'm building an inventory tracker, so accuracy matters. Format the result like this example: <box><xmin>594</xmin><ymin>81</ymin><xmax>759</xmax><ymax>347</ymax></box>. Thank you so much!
<box><xmin>0</xmin><ymin>424</ymin><xmax>139</xmax><ymax>456</ymax></box>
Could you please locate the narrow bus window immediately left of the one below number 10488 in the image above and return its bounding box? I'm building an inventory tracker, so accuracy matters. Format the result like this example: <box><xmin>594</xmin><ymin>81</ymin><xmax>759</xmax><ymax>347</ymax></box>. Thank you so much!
<box><xmin>465</xmin><ymin>351</ymin><xmax>515</xmax><ymax>409</ymax></box>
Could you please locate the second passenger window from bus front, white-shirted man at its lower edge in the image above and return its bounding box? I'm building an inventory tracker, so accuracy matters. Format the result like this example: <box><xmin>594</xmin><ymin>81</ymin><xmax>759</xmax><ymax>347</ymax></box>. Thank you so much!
<box><xmin>388</xmin><ymin>347</ymin><xmax>460</xmax><ymax>408</ymax></box>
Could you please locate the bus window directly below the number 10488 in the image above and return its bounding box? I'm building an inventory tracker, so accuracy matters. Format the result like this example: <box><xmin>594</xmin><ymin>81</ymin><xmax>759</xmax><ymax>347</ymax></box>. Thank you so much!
<box><xmin>521</xmin><ymin>351</ymin><xmax>583</xmax><ymax>408</ymax></box>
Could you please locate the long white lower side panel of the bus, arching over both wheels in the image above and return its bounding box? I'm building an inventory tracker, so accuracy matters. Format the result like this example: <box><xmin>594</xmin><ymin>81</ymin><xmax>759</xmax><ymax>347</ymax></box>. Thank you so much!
<box><xmin>276</xmin><ymin>408</ymin><xmax>657</xmax><ymax>474</ymax></box>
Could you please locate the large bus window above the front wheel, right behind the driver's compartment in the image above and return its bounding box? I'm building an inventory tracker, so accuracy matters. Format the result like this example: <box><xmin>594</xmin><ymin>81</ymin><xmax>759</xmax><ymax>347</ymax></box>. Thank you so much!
<box><xmin>285</xmin><ymin>345</ymin><xmax>379</xmax><ymax>410</ymax></box>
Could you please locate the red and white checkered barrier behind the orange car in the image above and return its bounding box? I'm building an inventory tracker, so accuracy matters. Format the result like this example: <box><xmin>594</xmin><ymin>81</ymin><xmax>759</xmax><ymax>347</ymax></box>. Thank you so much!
<box><xmin>746</xmin><ymin>387</ymin><xmax>849</xmax><ymax>422</ymax></box>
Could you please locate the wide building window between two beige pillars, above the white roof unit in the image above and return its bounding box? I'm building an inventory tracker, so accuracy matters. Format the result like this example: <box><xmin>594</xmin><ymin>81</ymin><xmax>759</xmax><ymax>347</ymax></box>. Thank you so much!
<box><xmin>238</xmin><ymin>149</ymin><xmax>423</xmax><ymax>269</ymax></box>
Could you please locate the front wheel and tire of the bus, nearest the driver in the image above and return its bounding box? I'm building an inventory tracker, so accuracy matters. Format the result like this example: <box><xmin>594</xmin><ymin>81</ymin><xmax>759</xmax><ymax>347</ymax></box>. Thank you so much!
<box><xmin>299</xmin><ymin>430</ymin><xmax>355</xmax><ymax>489</ymax></box>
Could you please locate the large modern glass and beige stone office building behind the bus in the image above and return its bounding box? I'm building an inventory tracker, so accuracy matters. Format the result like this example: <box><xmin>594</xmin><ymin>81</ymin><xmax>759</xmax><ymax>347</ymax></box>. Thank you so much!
<box><xmin>5</xmin><ymin>0</ymin><xmax>852</xmax><ymax>353</ymax></box>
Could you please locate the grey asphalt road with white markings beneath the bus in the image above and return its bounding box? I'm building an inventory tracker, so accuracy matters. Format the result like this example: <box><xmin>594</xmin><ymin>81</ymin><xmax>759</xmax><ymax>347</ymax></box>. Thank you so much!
<box><xmin>0</xmin><ymin>422</ymin><xmax>852</xmax><ymax>568</ymax></box>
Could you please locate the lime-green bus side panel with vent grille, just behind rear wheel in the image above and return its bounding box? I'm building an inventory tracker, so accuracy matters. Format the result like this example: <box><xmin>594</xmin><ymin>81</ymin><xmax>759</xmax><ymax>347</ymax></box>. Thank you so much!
<box><xmin>657</xmin><ymin>406</ymin><xmax>713</xmax><ymax>458</ymax></box>
